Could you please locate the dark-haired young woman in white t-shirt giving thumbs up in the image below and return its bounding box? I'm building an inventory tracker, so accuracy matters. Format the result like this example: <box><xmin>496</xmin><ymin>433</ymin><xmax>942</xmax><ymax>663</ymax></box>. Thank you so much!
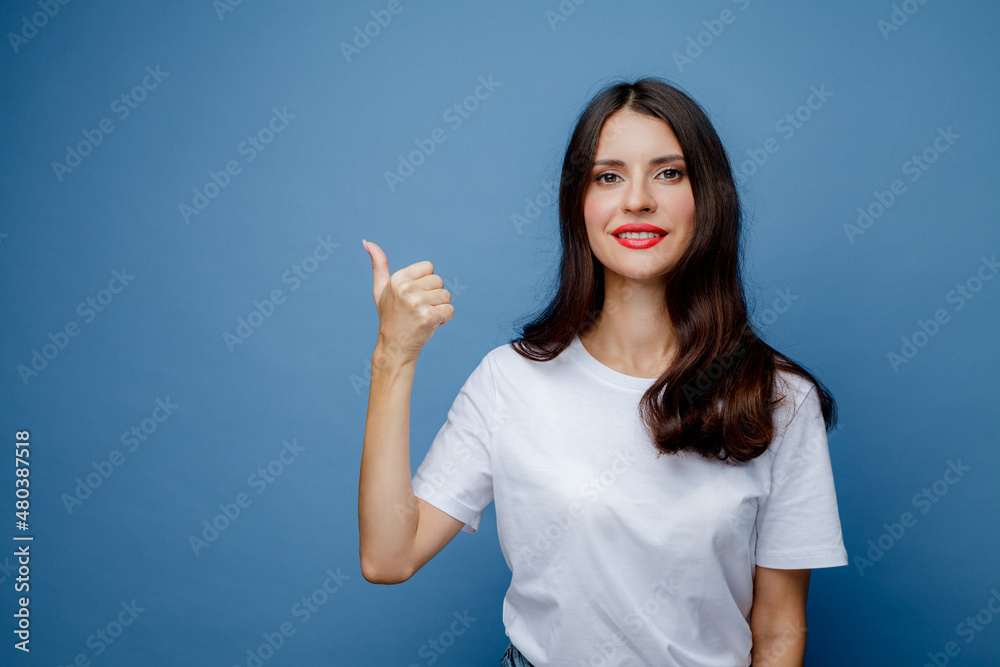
<box><xmin>358</xmin><ymin>78</ymin><xmax>848</xmax><ymax>667</ymax></box>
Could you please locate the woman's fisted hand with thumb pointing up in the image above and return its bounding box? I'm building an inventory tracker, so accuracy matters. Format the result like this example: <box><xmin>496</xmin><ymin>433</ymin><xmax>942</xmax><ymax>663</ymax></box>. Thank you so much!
<box><xmin>362</xmin><ymin>239</ymin><xmax>455</xmax><ymax>363</ymax></box>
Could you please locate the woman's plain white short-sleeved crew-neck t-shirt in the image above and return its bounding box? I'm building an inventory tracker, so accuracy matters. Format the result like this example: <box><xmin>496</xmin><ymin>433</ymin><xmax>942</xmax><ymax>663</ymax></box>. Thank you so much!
<box><xmin>413</xmin><ymin>337</ymin><xmax>848</xmax><ymax>667</ymax></box>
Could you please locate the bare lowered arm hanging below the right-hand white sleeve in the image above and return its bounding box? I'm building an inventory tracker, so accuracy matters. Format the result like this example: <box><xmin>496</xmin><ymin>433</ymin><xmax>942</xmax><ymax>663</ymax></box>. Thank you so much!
<box><xmin>750</xmin><ymin>565</ymin><xmax>812</xmax><ymax>667</ymax></box>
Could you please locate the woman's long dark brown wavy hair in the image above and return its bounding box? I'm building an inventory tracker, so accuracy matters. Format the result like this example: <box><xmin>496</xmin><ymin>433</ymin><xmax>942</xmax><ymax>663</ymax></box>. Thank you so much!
<box><xmin>511</xmin><ymin>78</ymin><xmax>837</xmax><ymax>462</ymax></box>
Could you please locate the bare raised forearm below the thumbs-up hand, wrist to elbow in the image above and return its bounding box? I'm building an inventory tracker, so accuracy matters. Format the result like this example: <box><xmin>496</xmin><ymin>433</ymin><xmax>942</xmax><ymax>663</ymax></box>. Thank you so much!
<box><xmin>358</xmin><ymin>345</ymin><xmax>418</xmax><ymax>581</ymax></box>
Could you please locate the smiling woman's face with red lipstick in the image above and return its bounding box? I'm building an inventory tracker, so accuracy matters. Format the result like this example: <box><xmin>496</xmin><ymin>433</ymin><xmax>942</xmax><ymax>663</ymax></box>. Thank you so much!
<box><xmin>583</xmin><ymin>109</ymin><xmax>695</xmax><ymax>279</ymax></box>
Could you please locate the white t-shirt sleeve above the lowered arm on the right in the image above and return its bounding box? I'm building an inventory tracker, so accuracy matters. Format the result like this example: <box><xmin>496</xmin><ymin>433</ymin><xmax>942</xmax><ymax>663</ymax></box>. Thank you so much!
<box><xmin>756</xmin><ymin>383</ymin><xmax>848</xmax><ymax>569</ymax></box>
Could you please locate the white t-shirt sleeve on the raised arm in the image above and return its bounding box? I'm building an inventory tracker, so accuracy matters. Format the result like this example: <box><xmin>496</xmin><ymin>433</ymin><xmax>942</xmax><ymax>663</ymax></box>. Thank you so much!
<box><xmin>412</xmin><ymin>355</ymin><xmax>496</xmax><ymax>534</ymax></box>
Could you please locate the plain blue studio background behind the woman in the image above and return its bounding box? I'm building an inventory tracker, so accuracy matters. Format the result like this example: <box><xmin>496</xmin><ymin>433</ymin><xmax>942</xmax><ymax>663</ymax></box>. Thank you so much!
<box><xmin>0</xmin><ymin>0</ymin><xmax>1000</xmax><ymax>666</ymax></box>
